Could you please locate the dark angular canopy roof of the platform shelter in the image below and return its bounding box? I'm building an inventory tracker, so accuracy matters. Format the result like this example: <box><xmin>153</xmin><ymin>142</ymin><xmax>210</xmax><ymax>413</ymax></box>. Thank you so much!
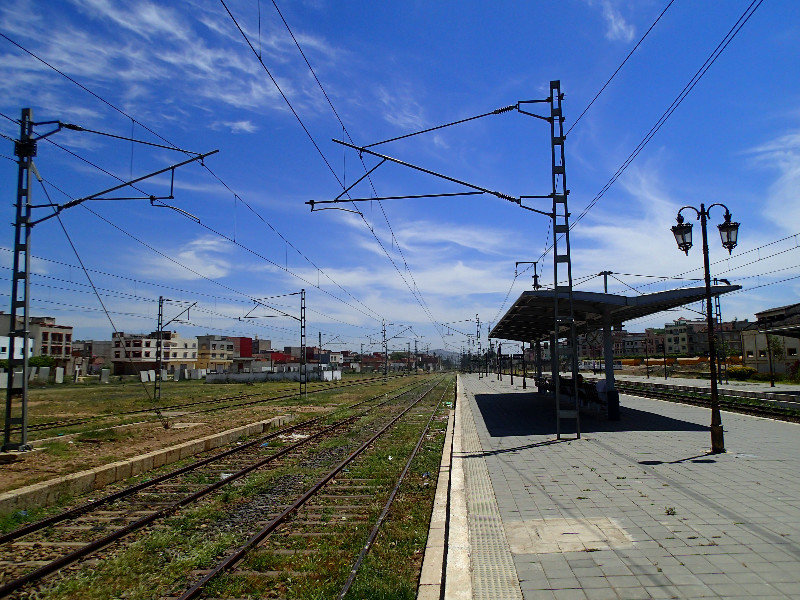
<box><xmin>489</xmin><ymin>285</ymin><xmax>742</xmax><ymax>342</ymax></box>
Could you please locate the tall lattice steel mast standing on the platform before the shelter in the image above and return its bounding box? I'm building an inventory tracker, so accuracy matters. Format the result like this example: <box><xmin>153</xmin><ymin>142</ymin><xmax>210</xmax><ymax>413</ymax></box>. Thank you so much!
<box><xmin>548</xmin><ymin>80</ymin><xmax>581</xmax><ymax>439</ymax></box>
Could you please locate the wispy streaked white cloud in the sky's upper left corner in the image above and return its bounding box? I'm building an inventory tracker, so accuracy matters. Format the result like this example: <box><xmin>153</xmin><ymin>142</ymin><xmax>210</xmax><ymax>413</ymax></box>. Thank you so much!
<box><xmin>0</xmin><ymin>0</ymin><xmax>343</xmax><ymax>123</ymax></box>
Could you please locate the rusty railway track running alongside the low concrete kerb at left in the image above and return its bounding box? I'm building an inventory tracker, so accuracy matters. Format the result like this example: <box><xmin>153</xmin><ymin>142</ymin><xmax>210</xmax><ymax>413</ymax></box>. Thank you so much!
<box><xmin>0</xmin><ymin>381</ymin><xmax>438</xmax><ymax>597</ymax></box>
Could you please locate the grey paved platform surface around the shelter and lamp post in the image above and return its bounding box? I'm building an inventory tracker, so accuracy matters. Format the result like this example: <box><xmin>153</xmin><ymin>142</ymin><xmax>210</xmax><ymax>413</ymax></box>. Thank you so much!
<box><xmin>445</xmin><ymin>375</ymin><xmax>800</xmax><ymax>600</ymax></box>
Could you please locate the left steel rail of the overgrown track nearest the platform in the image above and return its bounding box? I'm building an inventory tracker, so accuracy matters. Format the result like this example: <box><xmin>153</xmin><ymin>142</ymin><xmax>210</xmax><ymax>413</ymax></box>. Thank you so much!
<box><xmin>173</xmin><ymin>379</ymin><xmax>443</xmax><ymax>600</ymax></box>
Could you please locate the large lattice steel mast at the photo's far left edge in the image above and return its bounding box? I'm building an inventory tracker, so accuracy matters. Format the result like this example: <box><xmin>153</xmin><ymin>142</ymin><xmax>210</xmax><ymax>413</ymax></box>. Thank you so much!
<box><xmin>3</xmin><ymin>108</ymin><xmax>36</xmax><ymax>451</ymax></box>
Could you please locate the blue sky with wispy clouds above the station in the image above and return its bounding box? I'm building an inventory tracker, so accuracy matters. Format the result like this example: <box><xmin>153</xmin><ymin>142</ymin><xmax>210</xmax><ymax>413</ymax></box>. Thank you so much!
<box><xmin>0</xmin><ymin>0</ymin><xmax>800</xmax><ymax>350</ymax></box>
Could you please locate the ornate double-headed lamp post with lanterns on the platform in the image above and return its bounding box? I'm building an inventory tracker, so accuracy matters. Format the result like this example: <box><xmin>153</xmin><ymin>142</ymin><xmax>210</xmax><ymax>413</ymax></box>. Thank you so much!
<box><xmin>672</xmin><ymin>202</ymin><xmax>739</xmax><ymax>454</ymax></box>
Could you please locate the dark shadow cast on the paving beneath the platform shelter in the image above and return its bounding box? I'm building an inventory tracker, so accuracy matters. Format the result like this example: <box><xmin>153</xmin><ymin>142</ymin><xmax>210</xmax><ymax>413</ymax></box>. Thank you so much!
<box><xmin>475</xmin><ymin>392</ymin><xmax>708</xmax><ymax>437</ymax></box>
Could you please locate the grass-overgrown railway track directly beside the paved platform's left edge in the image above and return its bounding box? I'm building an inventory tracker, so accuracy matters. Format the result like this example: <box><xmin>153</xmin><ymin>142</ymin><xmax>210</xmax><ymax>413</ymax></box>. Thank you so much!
<box><xmin>169</xmin><ymin>380</ymin><xmax>450</xmax><ymax>600</ymax></box>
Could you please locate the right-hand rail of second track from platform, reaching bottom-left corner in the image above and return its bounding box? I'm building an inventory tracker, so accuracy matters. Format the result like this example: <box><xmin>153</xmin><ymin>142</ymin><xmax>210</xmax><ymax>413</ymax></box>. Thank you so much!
<box><xmin>0</xmin><ymin>383</ymin><xmax>428</xmax><ymax>597</ymax></box>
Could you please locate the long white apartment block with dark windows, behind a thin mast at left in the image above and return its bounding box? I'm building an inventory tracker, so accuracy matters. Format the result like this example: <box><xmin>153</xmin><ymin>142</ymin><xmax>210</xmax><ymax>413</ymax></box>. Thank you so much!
<box><xmin>111</xmin><ymin>331</ymin><xmax>198</xmax><ymax>375</ymax></box>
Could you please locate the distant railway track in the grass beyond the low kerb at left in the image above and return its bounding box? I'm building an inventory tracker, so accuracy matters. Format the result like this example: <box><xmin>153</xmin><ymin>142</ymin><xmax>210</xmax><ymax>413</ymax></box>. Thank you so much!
<box><xmin>19</xmin><ymin>375</ymin><xmax>412</xmax><ymax>441</ymax></box>
